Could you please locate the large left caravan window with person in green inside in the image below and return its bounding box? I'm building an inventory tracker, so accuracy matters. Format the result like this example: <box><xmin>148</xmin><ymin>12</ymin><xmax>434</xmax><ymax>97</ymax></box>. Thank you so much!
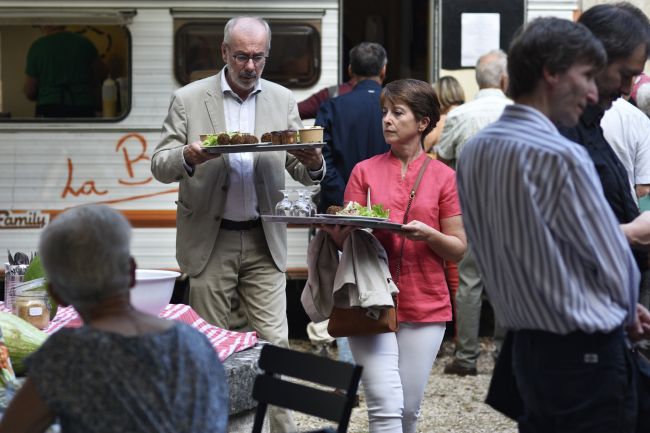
<box><xmin>0</xmin><ymin>24</ymin><xmax>131</xmax><ymax>123</ymax></box>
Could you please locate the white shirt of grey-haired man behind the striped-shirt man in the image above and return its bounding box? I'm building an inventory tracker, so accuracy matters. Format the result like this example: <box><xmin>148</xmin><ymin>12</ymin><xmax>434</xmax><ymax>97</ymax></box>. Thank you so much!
<box><xmin>436</xmin><ymin>89</ymin><xmax>512</xmax><ymax>167</ymax></box>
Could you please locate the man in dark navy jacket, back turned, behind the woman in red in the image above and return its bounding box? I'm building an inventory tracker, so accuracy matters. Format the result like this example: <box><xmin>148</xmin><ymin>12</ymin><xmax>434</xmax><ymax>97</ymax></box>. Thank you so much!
<box><xmin>315</xmin><ymin>42</ymin><xmax>389</xmax><ymax>213</ymax></box>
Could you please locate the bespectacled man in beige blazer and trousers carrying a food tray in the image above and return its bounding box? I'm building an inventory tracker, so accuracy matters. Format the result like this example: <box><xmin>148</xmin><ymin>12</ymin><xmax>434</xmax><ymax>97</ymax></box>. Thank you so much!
<box><xmin>151</xmin><ymin>17</ymin><xmax>324</xmax><ymax>431</ymax></box>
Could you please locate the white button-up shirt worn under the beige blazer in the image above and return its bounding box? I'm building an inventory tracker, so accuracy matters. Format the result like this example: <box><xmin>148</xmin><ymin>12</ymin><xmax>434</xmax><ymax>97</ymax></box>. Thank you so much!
<box><xmin>221</xmin><ymin>68</ymin><xmax>262</xmax><ymax>221</ymax></box>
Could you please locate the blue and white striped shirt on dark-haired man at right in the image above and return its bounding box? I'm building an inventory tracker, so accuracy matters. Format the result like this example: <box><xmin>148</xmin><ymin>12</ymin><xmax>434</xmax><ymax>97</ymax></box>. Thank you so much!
<box><xmin>458</xmin><ymin>104</ymin><xmax>639</xmax><ymax>334</ymax></box>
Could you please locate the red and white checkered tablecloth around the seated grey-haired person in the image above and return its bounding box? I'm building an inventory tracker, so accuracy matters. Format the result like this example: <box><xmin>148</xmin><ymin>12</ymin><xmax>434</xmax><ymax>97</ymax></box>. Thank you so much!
<box><xmin>0</xmin><ymin>302</ymin><xmax>257</xmax><ymax>361</ymax></box>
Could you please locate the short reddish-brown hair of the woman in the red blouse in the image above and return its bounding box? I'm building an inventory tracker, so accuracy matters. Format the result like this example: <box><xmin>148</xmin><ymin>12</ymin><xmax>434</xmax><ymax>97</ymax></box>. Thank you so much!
<box><xmin>381</xmin><ymin>78</ymin><xmax>440</xmax><ymax>147</ymax></box>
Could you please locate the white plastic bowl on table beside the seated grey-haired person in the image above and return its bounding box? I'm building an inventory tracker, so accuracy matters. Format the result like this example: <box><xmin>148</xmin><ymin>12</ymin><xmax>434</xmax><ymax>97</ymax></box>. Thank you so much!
<box><xmin>131</xmin><ymin>269</ymin><xmax>180</xmax><ymax>316</ymax></box>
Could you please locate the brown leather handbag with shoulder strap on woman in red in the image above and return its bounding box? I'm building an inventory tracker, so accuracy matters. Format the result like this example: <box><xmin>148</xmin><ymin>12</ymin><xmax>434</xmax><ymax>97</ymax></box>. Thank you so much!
<box><xmin>327</xmin><ymin>158</ymin><xmax>431</xmax><ymax>337</ymax></box>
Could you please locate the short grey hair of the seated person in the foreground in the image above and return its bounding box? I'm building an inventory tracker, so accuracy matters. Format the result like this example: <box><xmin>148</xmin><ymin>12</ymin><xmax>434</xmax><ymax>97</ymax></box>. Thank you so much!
<box><xmin>38</xmin><ymin>205</ymin><xmax>131</xmax><ymax>308</ymax></box>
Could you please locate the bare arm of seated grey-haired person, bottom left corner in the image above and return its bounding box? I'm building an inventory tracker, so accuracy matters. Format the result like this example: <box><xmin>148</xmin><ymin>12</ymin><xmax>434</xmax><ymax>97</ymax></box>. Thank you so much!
<box><xmin>0</xmin><ymin>378</ymin><xmax>54</xmax><ymax>433</ymax></box>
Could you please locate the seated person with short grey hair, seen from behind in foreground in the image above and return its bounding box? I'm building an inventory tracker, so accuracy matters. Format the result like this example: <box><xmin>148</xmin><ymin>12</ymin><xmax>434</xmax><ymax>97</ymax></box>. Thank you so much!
<box><xmin>0</xmin><ymin>206</ymin><xmax>228</xmax><ymax>433</ymax></box>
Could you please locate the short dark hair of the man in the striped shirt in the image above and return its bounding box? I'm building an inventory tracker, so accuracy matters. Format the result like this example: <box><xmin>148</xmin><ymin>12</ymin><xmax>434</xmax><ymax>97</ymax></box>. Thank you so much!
<box><xmin>508</xmin><ymin>17</ymin><xmax>607</xmax><ymax>98</ymax></box>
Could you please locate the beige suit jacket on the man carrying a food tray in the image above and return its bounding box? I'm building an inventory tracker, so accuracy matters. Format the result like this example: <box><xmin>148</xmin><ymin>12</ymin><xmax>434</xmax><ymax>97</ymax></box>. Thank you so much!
<box><xmin>151</xmin><ymin>72</ymin><xmax>318</xmax><ymax>276</ymax></box>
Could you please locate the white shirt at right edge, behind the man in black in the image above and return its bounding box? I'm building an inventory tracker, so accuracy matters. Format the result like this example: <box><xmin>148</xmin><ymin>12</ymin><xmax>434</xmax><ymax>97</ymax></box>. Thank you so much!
<box><xmin>600</xmin><ymin>98</ymin><xmax>650</xmax><ymax>200</ymax></box>
